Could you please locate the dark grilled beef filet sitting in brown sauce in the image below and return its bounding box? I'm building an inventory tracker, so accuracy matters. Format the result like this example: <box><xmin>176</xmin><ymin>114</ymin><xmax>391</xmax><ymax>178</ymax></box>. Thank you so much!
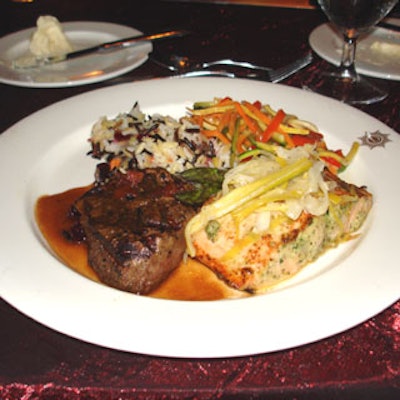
<box><xmin>75</xmin><ymin>164</ymin><xmax>196</xmax><ymax>294</ymax></box>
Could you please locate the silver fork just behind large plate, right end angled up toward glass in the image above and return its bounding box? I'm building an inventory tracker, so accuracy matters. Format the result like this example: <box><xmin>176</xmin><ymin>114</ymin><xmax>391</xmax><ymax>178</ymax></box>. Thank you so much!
<box><xmin>158</xmin><ymin>52</ymin><xmax>312</xmax><ymax>83</ymax></box>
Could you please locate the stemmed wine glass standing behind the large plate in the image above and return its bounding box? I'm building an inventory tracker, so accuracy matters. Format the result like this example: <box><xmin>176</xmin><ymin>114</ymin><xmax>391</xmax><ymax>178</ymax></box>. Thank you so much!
<box><xmin>304</xmin><ymin>0</ymin><xmax>398</xmax><ymax>104</ymax></box>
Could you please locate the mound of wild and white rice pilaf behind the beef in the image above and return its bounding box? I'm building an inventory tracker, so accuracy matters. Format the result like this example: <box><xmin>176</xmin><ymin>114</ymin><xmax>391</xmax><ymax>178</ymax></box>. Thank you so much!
<box><xmin>90</xmin><ymin>103</ymin><xmax>230</xmax><ymax>174</ymax></box>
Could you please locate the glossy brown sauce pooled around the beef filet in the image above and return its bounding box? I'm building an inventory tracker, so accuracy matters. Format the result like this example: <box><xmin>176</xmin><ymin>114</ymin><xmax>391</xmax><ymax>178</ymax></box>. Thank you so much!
<box><xmin>35</xmin><ymin>187</ymin><xmax>247</xmax><ymax>300</ymax></box>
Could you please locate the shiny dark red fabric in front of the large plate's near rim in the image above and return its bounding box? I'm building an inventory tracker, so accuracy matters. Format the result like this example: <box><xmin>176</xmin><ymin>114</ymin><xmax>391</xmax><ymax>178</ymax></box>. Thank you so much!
<box><xmin>0</xmin><ymin>302</ymin><xmax>400</xmax><ymax>400</ymax></box>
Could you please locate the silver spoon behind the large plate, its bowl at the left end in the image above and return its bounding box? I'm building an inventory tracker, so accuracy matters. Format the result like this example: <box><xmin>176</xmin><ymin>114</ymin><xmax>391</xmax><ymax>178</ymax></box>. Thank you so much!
<box><xmin>152</xmin><ymin>54</ymin><xmax>271</xmax><ymax>73</ymax></box>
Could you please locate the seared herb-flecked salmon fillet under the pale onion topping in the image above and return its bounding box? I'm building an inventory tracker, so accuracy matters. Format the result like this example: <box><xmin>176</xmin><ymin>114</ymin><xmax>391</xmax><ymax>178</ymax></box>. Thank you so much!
<box><xmin>192</xmin><ymin>170</ymin><xmax>372</xmax><ymax>293</ymax></box>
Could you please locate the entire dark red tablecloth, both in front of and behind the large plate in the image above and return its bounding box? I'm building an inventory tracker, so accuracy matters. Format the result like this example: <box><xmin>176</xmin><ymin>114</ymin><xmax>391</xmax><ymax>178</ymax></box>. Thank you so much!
<box><xmin>0</xmin><ymin>0</ymin><xmax>400</xmax><ymax>399</ymax></box>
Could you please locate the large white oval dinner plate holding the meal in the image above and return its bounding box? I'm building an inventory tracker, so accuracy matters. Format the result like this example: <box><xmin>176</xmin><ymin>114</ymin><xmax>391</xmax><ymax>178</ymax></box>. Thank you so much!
<box><xmin>0</xmin><ymin>78</ymin><xmax>400</xmax><ymax>358</ymax></box>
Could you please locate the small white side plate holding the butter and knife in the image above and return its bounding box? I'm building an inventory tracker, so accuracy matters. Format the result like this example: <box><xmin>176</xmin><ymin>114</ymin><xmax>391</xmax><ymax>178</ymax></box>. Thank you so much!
<box><xmin>0</xmin><ymin>21</ymin><xmax>152</xmax><ymax>88</ymax></box>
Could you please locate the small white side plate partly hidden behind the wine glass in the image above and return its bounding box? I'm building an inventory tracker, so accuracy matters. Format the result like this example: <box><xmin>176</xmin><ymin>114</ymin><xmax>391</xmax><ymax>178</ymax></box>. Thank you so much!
<box><xmin>309</xmin><ymin>18</ymin><xmax>400</xmax><ymax>80</ymax></box>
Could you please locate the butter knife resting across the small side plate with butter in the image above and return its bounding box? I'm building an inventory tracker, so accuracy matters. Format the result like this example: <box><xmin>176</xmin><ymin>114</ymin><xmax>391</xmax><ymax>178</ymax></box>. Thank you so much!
<box><xmin>13</xmin><ymin>30</ymin><xmax>189</xmax><ymax>68</ymax></box>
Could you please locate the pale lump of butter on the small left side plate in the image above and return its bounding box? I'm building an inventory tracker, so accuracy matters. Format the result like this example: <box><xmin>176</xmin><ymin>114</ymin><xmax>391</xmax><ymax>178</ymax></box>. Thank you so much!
<box><xmin>29</xmin><ymin>15</ymin><xmax>73</xmax><ymax>57</ymax></box>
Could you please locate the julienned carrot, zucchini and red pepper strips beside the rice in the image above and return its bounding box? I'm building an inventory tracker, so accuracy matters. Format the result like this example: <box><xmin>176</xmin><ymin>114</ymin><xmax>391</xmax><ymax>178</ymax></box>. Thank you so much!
<box><xmin>188</xmin><ymin>97</ymin><xmax>359</xmax><ymax>174</ymax></box>
